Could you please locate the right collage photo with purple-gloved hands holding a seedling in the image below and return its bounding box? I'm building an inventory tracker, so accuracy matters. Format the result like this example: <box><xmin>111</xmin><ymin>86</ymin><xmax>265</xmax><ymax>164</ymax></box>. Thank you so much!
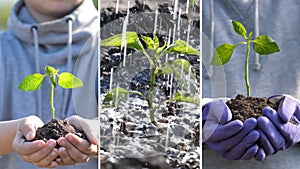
<box><xmin>202</xmin><ymin>0</ymin><xmax>300</xmax><ymax>169</ymax></box>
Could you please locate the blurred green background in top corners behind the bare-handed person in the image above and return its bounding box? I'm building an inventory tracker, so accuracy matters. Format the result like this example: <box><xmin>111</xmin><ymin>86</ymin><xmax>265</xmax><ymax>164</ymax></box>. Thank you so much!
<box><xmin>0</xmin><ymin>0</ymin><xmax>98</xmax><ymax>31</ymax></box>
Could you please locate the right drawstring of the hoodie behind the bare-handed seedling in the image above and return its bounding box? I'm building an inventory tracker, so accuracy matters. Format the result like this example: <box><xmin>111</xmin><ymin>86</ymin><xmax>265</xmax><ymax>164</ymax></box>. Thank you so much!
<box><xmin>62</xmin><ymin>18</ymin><xmax>73</xmax><ymax>115</ymax></box>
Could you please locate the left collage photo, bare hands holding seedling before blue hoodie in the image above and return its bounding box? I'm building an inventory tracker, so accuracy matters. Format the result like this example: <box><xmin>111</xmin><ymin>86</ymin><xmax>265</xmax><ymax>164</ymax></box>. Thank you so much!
<box><xmin>0</xmin><ymin>0</ymin><xmax>100</xmax><ymax>169</ymax></box>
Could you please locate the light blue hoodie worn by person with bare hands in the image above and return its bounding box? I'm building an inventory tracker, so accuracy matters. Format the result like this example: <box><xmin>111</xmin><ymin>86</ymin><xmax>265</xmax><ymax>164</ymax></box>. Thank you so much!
<box><xmin>0</xmin><ymin>0</ymin><xmax>100</xmax><ymax>169</ymax></box>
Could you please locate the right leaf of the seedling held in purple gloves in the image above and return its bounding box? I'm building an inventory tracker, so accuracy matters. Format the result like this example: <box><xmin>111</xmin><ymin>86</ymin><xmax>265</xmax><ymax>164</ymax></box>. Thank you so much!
<box><xmin>253</xmin><ymin>35</ymin><xmax>280</xmax><ymax>55</ymax></box>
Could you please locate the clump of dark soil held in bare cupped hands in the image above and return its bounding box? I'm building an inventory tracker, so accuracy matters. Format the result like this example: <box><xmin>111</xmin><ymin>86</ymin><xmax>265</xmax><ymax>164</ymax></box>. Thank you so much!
<box><xmin>33</xmin><ymin>119</ymin><xmax>87</xmax><ymax>146</ymax></box>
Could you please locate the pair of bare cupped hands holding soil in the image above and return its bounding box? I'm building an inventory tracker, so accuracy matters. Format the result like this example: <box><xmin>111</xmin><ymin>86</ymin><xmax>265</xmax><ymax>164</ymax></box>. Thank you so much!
<box><xmin>12</xmin><ymin>115</ymin><xmax>98</xmax><ymax>168</ymax></box>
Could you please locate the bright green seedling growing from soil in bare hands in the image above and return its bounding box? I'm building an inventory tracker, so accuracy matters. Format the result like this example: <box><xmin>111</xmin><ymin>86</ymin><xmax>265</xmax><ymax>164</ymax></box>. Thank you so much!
<box><xmin>19</xmin><ymin>66</ymin><xmax>83</xmax><ymax>120</ymax></box>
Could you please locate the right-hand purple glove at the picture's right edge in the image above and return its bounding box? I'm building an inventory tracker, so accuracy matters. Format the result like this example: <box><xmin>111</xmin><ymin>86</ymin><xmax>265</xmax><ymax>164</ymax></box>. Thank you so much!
<box><xmin>257</xmin><ymin>95</ymin><xmax>300</xmax><ymax>155</ymax></box>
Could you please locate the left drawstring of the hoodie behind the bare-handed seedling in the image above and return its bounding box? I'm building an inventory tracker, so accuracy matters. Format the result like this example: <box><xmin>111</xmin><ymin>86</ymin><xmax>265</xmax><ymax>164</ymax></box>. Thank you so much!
<box><xmin>31</xmin><ymin>26</ymin><xmax>42</xmax><ymax>117</ymax></box>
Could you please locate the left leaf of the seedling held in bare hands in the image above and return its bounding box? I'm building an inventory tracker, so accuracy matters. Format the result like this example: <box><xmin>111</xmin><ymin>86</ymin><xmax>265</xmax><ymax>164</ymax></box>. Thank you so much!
<box><xmin>18</xmin><ymin>73</ymin><xmax>45</xmax><ymax>91</ymax></box>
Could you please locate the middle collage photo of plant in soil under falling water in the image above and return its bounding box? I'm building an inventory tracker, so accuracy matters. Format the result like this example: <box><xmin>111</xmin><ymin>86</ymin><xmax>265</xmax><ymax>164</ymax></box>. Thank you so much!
<box><xmin>99</xmin><ymin>0</ymin><xmax>201</xmax><ymax>169</ymax></box>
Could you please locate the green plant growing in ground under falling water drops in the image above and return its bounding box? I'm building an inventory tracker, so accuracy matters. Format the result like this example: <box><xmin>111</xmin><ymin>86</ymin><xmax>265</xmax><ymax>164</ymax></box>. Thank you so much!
<box><xmin>101</xmin><ymin>32</ymin><xmax>200</xmax><ymax>125</ymax></box>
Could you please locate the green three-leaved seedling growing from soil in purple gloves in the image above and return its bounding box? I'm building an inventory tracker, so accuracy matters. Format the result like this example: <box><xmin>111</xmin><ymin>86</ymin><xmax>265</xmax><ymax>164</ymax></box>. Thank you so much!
<box><xmin>211</xmin><ymin>20</ymin><xmax>280</xmax><ymax>96</ymax></box>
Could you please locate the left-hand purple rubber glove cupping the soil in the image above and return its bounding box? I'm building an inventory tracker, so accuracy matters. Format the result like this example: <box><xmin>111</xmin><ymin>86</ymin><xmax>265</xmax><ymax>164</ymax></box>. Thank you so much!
<box><xmin>202</xmin><ymin>99</ymin><xmax>265</xmax><ymax>160</ymax></box>
